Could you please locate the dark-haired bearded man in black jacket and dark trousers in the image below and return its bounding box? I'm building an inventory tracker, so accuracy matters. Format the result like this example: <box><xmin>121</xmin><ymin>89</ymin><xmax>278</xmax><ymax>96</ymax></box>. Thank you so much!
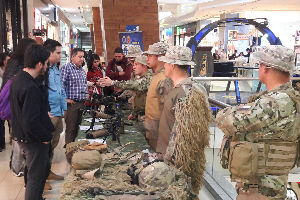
<box><xmin>10</xmin><ymin>44</ymin><xmax>54</xmax><ymax>200</ymax></box>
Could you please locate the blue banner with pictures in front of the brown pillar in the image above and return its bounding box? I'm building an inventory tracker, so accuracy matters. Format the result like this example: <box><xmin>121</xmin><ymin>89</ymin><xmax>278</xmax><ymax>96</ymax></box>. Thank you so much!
<box><xmin>119</xmin><ymin>31</ymin><xmax>144</xmax><ymax>55</ymax></box>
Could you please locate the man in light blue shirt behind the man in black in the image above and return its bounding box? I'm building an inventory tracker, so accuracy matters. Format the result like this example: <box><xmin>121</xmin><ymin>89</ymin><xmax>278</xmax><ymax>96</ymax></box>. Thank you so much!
<box><xmin>44</xmin><ymin>39</ymin><xmax>67</xmax><ymax>183</ymax></box>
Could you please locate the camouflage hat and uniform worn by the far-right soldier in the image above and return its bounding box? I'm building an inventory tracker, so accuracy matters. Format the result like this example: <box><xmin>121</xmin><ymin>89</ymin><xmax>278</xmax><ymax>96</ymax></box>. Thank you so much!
<box><xmin>217</xmin><ymin>46</ymin><xmax>300</xmax><ymax>199</ymax></box>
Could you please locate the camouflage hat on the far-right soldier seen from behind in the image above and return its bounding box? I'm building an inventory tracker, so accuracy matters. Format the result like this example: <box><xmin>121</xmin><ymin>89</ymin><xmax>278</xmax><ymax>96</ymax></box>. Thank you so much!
<box><xmin>250</xmin><ymin>45</ymin><xmax>296</xmax><ymax>74</ymax></box>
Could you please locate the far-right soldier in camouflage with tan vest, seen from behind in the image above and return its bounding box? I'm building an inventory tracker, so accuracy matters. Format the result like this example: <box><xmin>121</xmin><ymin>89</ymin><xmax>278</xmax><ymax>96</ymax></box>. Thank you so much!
<box><xmin>217</xmin><ymin>45</ymin><xmax>300</xmax><ymax>199</ymax></box>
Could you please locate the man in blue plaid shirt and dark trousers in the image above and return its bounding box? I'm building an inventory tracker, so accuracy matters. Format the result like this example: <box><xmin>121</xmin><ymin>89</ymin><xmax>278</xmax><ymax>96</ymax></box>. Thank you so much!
<box><xmin>61</xmin><ymin>48</ymin><xmax>88</xmax><ymax>144</ymax></box>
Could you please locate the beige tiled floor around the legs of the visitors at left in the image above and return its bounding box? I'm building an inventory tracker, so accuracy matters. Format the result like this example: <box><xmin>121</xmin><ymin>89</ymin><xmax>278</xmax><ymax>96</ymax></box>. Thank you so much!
<box><xmin>0</xmin><ymin>122</ymin><xmax>70</xmax><ymax>200</ymax></box>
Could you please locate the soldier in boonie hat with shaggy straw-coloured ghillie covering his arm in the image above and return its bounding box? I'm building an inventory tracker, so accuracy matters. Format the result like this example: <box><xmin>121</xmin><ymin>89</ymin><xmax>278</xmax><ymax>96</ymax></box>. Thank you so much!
<box><xmin>156</xmin><ymin>46</ymin><xmax>211</xmax><ymax>194</ymax></box>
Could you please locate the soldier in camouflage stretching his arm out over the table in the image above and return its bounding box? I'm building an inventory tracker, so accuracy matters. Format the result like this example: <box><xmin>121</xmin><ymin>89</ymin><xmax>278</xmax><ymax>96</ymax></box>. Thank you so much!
<box><xmin>99</xmin><ymin>56</ymin><xmax>152</xmax><ymax>120</ymax></box>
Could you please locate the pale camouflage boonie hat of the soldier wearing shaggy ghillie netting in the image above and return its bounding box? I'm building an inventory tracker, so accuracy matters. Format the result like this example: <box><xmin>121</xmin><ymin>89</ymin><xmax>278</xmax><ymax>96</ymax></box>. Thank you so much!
<box><xmin>158</xmin><ymin>46</ymin><xmax>195</xmax><ymax>65</ymax></box>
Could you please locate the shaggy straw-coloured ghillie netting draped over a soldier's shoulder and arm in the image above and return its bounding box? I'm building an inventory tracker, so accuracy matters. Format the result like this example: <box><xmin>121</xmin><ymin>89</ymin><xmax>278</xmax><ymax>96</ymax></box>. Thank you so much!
<box><xmin>174</xmin><ymin>87</ymin><xmax>212</xmax><ymax>194</ymax></box>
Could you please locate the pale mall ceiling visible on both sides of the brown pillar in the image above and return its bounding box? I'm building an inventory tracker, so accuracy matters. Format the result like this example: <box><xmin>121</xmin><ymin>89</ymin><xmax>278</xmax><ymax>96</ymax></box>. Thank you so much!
<box><xmin>44</xmin><ymin>0</ymin><xmax>300</xmax><ymax>31</ymax></box>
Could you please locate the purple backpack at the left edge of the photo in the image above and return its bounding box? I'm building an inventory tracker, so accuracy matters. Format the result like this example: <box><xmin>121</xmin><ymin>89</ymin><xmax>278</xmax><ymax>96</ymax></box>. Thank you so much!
<box><xmin>0</xmin><ymin>79</ymin><xmax>12</xmax><ymax>120</ymax></box>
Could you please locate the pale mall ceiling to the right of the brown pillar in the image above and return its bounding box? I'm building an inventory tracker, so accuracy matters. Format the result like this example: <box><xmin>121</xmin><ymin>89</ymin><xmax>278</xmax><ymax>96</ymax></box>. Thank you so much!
<box><xmin>158</xmin><ymin>0</ymin><xmax>300</xmax><ymax>27</ymax></box>
